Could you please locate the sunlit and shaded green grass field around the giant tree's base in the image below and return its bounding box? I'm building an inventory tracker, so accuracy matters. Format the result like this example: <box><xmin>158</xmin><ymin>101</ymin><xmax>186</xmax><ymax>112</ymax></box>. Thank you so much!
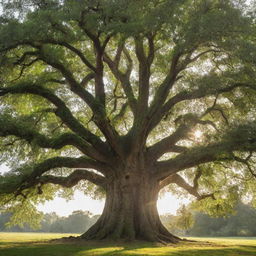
<box><xmin>0</xmin><ymin>233</ymin><xmax>256</xmax><ymax>256</ymax></box>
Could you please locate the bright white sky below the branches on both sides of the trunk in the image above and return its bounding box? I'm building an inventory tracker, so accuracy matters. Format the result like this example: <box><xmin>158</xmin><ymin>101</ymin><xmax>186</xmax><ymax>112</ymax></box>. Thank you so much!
<box><xmin>0</xmin><ymin>165</ymin><xmax>189</xmax><ymax>216</ymax></box>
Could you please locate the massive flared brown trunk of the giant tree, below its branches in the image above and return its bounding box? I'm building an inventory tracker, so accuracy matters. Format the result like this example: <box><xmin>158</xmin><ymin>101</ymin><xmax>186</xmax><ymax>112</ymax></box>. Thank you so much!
<box><xmin>81</xmin><ymin>173</ymin><xmax>180</xmax><ymax>243</ymax></box>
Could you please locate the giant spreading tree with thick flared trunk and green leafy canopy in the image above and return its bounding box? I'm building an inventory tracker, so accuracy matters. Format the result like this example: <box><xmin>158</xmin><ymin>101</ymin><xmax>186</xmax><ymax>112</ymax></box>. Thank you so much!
<box><xmin>0</xmin><ymin>0</ymin><xmax>256</xmax><ymax>242</ymax></box>
